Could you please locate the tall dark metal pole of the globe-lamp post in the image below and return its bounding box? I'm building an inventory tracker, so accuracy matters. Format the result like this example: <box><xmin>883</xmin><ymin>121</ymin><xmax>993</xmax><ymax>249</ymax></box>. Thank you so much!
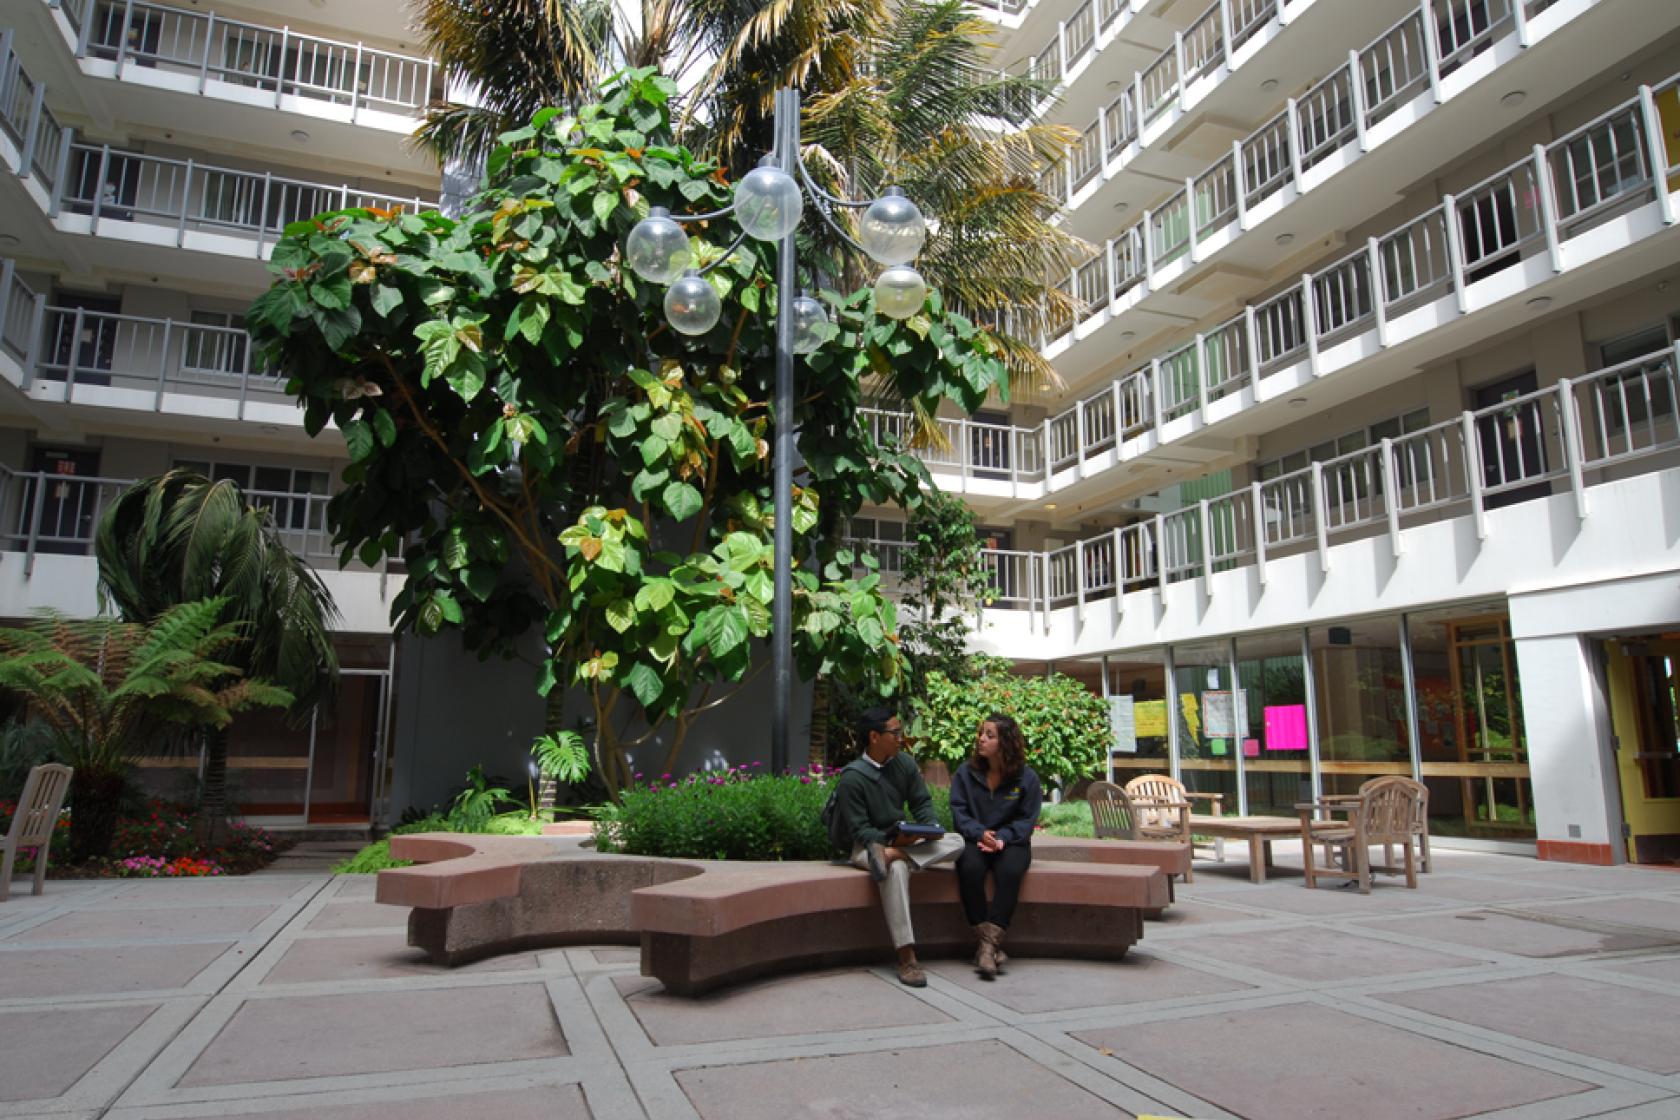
<box><xmin>769</xmin><ymin>89</ymin><xmax>800</xmax><ymax>774</ymax></box>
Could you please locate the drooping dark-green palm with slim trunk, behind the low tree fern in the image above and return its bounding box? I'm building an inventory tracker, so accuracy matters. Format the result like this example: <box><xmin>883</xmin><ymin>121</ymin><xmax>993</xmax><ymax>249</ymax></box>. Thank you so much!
<box><xmin>94</xmin><ymin>470</ymin><xmax>338</xmax><ymax>835</ymax></box>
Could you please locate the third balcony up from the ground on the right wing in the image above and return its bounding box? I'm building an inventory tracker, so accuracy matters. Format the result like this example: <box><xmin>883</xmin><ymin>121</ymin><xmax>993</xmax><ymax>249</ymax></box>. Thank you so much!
<box><xmin>1045</xmin><ymin>0</ymin><xmax>1677</xmax><ymax>386</ymax></box>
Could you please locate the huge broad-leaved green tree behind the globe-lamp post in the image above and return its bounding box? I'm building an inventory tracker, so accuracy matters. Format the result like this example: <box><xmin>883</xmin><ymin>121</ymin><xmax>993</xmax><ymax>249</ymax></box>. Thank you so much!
<box><xmin>249</xmin><ymin>71</ymin><xmax>1003</xmax><ymax>789</ymax></box>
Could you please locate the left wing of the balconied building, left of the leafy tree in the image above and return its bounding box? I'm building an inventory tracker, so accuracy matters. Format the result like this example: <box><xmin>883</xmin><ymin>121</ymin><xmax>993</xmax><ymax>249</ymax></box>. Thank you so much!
<box><xmin>0</xmin><ymin>0</ymin><xmax>440</xmax><ymax>826</ymax></box>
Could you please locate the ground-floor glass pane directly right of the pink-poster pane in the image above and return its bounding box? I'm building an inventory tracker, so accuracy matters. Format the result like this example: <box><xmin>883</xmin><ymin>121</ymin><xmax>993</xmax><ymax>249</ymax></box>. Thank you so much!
<box><xmin>1309</xmin><ymin>616</ymin><xmax>1411</xmax><ymax>794</ymax></box>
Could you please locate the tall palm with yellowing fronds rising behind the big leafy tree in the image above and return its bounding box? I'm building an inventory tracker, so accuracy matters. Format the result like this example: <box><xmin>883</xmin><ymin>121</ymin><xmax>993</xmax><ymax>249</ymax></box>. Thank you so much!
<box><xmin>417</xmin><ymin>0</ymin><xmax>1087</xmax><ymax>391</ymax></box>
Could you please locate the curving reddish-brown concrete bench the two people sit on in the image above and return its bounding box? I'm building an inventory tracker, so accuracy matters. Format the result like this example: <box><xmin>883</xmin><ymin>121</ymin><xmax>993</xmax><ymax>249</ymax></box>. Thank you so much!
<box><xmin>375</xmin><ymin>833</ymin><xmax>1189</xmax><ymax>994</ymax></box>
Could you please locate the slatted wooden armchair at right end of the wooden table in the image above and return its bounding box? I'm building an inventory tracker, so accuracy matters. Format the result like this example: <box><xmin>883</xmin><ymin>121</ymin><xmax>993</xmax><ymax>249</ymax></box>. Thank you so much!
<box><xmin>1295</xmin><ymin>776</ymin><xmax>1430</xmax><ymax>895</ymax></box>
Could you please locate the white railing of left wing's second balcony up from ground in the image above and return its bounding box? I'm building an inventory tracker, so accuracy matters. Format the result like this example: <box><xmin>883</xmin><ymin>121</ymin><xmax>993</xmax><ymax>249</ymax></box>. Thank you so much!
<box><xmin>0</xmin><ymin>260</ymin><xmax>291</xmax><ymax>416</ymax></box>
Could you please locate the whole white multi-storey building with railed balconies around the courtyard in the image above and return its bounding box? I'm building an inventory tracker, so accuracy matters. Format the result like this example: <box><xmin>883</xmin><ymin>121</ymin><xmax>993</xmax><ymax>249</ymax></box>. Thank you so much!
<box><xmin>0</xmin><ymin>0</ymin><xmax>1680</xmax><ymax>861</ymax></box>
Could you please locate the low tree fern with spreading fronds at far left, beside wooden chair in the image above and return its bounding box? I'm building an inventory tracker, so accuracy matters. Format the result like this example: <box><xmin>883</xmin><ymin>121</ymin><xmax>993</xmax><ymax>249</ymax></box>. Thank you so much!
<box><xmin>0</xmin><ymin>599</ymin><xmax>292</xmax><ymax>860</ymax></box>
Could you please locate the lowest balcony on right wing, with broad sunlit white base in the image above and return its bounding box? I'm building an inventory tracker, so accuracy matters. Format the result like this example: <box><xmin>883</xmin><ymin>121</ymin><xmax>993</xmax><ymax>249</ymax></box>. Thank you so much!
<box><xmin>857</xmin><ymin>349</ymin><xmax>1680</xmax><ymax>660</ymax></box>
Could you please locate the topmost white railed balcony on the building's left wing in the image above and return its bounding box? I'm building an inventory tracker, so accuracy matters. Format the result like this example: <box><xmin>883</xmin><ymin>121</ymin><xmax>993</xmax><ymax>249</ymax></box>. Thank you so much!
<box><xmin>17</xmin><ymin>0</ymin><xmax>440</xmax><ymax>173</ymax></box>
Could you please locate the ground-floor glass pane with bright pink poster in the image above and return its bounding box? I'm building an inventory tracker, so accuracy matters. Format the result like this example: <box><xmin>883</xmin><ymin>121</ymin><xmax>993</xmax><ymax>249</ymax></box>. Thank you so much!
<box><xmin>1236</xmin><ymin>630</ymin><xmax>1312</xmax><ymax>816</ymax></box>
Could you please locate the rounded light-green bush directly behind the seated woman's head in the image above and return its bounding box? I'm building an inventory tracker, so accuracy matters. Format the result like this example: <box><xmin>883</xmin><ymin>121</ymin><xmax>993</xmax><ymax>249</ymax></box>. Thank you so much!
<box><xmin>917</xmin><ymin>657</ymin><xmax>1109</xmax><ymax>782</ymax></box>
